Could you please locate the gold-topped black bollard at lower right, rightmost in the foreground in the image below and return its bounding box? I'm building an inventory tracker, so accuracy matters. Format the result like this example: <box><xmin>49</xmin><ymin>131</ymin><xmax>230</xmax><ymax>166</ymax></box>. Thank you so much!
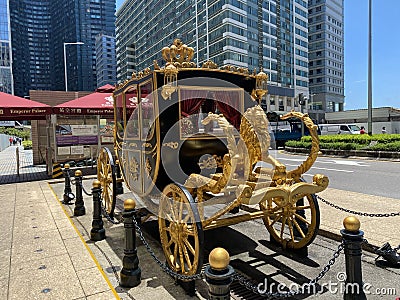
<box><xmin>340</xmin><ymin>216</ymin><xmax>367</xmax><ymax>300</ymax></box>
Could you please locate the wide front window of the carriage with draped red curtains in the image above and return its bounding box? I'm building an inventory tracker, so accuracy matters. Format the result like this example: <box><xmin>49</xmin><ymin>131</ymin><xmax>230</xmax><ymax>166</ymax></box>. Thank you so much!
<box><xmin>180</xmin><ymin>89</ymin><xmax>243</xmax><ymax>138</ymax></box>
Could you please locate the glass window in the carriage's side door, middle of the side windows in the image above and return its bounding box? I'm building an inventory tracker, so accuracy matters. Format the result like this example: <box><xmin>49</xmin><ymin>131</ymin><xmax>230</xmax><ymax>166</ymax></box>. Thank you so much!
<box><xmin>125</xmin><ymin>86</ymin><xmax>139</xmax><ymax>139</ymax></box>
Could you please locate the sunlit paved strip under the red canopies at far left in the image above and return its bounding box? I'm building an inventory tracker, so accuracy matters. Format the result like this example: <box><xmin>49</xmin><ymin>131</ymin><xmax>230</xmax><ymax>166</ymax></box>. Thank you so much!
<box><xmin>0</xmin><ymin>146</ymin><xmax>49</xmax><ymax>184</ymax></box>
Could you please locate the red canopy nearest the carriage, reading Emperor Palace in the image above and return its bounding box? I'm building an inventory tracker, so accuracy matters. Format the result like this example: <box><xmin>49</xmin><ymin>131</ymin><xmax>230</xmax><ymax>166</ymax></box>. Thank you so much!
<box><xmin>53</xmin><ymin>84</ymin><xmax>114</xmax><ymax>115</ymax></box>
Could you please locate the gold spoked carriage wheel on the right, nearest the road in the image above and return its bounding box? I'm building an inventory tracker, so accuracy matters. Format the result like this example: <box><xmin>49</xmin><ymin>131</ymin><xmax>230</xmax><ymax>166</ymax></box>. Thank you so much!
<box><xmin>260</xmin><ymin>194</ymin><xmax>320</xmax><ymax>249</ymax></box>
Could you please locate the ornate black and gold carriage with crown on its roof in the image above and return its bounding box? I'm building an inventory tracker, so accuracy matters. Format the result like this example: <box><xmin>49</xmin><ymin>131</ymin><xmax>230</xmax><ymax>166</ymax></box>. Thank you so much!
<box><xmin>98</xmin><ymin>40</ymin><xmax>329</xmax><ymax>275</ymax></box>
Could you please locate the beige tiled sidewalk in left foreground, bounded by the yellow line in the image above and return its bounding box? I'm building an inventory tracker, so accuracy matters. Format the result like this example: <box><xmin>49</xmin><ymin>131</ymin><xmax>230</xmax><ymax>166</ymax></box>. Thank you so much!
<box><xmin>0</xmin><ymin>181</ymin><xmax>118</xmax><ymax>299</ymax></box>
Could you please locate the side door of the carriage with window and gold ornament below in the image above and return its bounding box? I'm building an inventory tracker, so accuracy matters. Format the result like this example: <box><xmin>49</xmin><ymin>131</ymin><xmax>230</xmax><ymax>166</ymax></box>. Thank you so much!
<box><xmin>122</xmin><ymin>85</ymin><xmax>143</xmax><ymax>194</ymax></box>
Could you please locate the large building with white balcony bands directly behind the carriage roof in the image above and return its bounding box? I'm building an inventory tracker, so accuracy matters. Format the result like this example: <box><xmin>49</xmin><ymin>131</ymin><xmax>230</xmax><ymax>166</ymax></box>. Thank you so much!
<box><xmin>116</xmin><ymin>0</ymin><xmax>308</xmax><ymax>110</ymax></box>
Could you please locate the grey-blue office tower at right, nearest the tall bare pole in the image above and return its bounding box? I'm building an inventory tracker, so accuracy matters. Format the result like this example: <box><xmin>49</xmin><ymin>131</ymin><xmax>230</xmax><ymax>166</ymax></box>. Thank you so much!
<box><xmin>308</xmin><ymin>0</ymin><xmax>344</xmax><ymax>121</ymax></box>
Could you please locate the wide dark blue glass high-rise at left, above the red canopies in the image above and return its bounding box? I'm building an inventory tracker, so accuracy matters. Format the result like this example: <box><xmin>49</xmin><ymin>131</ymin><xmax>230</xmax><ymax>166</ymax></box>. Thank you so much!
<box><xmin>9</xmin><ymin>0</ymin><xmax>115</xmax><ymax>96</ymax></box>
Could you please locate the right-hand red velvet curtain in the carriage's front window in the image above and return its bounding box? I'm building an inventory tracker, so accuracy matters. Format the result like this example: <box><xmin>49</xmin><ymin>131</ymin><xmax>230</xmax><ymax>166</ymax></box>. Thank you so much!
<box><xmin>215</xmin><ymin>91</ymin><xmax>242</xmax><ymax>130</ymax></box>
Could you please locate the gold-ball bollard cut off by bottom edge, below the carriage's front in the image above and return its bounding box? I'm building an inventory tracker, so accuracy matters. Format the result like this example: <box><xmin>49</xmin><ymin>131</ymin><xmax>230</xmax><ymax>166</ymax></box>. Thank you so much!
<box><xmin>204</xmin><ymin>248</ymin><xmax>235</xmax><ymax>300</ymax></box>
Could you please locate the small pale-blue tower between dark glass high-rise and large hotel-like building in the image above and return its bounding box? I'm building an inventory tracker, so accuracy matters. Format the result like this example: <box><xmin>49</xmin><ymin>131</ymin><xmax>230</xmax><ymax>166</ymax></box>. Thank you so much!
<box><xmin>96</xmin><ymin>34</ymin><xmax>117</xmax><ymax>87</ymax></box>
